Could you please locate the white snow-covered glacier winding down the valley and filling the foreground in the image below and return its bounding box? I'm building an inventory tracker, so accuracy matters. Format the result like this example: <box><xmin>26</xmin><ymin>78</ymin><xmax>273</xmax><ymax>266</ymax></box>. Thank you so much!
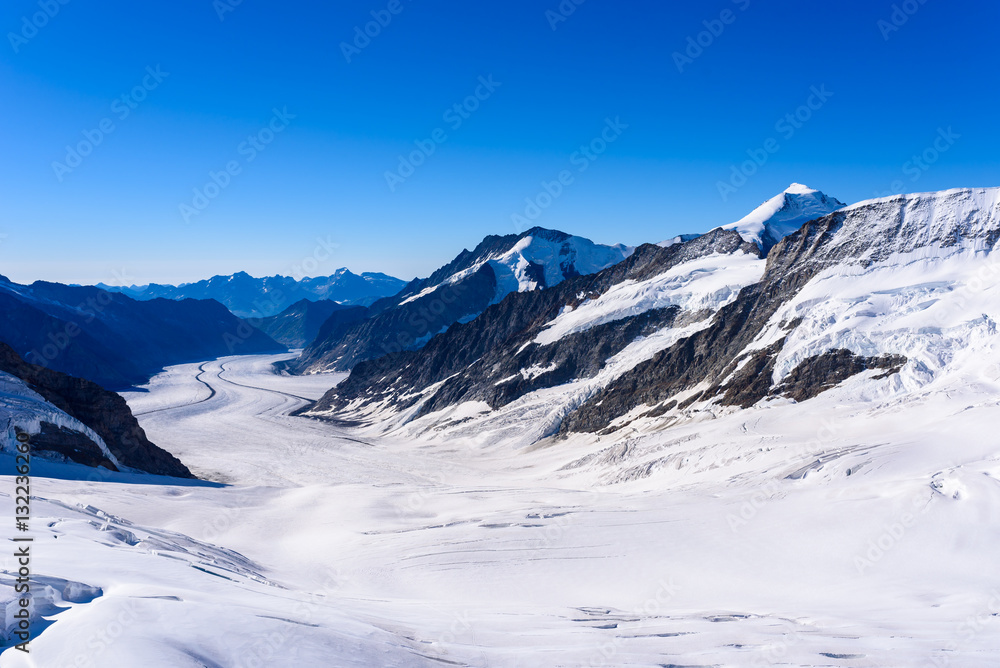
<box><xmin>0</xmin><ymin>356</ymin><xmax>1000</xmax><ymax>668</ymax></box>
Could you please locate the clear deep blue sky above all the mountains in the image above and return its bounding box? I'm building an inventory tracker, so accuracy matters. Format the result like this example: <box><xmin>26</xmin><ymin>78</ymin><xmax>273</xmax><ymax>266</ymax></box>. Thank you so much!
<box><xmin>0</xmin><ymin>0</ymin><xmax>1000</xmax><ymax>283</ymax></box>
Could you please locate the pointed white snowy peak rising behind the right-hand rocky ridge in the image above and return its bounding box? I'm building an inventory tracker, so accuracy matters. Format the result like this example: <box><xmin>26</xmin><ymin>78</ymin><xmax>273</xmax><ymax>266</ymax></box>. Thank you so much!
<box><xmin>722</xmin><ymin>183</ymin><xmax>846</xmax><ymax>255</ymax></box>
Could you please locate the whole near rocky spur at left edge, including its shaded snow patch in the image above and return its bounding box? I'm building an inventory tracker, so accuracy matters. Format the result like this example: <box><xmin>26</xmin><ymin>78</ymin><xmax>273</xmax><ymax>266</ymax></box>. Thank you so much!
<box><xmin>0</xmin><ymin>343</ymin><xmax>194</xmax><ymax>478</ymax></box>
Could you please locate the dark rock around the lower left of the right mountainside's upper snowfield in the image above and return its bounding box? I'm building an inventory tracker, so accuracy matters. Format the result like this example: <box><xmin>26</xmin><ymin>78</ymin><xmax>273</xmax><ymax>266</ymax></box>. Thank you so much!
<box><xmin>314</xmin><ymin>230</ymin><xmax>756</xmax><ymax>413</ymax></box>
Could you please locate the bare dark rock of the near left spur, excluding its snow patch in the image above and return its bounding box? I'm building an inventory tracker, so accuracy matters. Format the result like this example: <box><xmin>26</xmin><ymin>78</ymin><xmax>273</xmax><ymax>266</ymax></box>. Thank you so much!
<box><xmin>0</xmin><ymin>343</ymin><xmax>194</xmax><ymax>478</ymax></box>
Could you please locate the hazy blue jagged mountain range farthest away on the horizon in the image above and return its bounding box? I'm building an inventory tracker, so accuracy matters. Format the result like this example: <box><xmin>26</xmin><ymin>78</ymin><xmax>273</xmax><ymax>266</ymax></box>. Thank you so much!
<box><xmin>97</xmin><ymin>269</ymin><xmax>406</xmax><ymax>318</ymax></box>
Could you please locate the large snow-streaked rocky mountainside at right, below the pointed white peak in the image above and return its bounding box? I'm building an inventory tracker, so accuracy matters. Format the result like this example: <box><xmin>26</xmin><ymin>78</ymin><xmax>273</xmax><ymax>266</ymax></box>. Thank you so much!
<box><xmin>300</xmin><ymin>189</ymin><xmax>1000</xmax><ymax>444</ymax></box>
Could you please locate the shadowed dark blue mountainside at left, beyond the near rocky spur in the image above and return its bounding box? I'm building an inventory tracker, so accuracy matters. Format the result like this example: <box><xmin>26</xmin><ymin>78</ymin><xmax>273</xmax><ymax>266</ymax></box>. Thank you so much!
<box><xmin>0</xmin><ymin>280</ymin><xmax>286</xmax><ymax>389</ymax></box>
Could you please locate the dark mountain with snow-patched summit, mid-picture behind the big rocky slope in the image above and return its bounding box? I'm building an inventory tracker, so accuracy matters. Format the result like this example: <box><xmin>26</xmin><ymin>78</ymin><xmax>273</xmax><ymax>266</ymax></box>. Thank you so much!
<box><xmin>288</xmin><ymin>227</ymin><xmax>633</xmax><ymax>373</ymax></box>
